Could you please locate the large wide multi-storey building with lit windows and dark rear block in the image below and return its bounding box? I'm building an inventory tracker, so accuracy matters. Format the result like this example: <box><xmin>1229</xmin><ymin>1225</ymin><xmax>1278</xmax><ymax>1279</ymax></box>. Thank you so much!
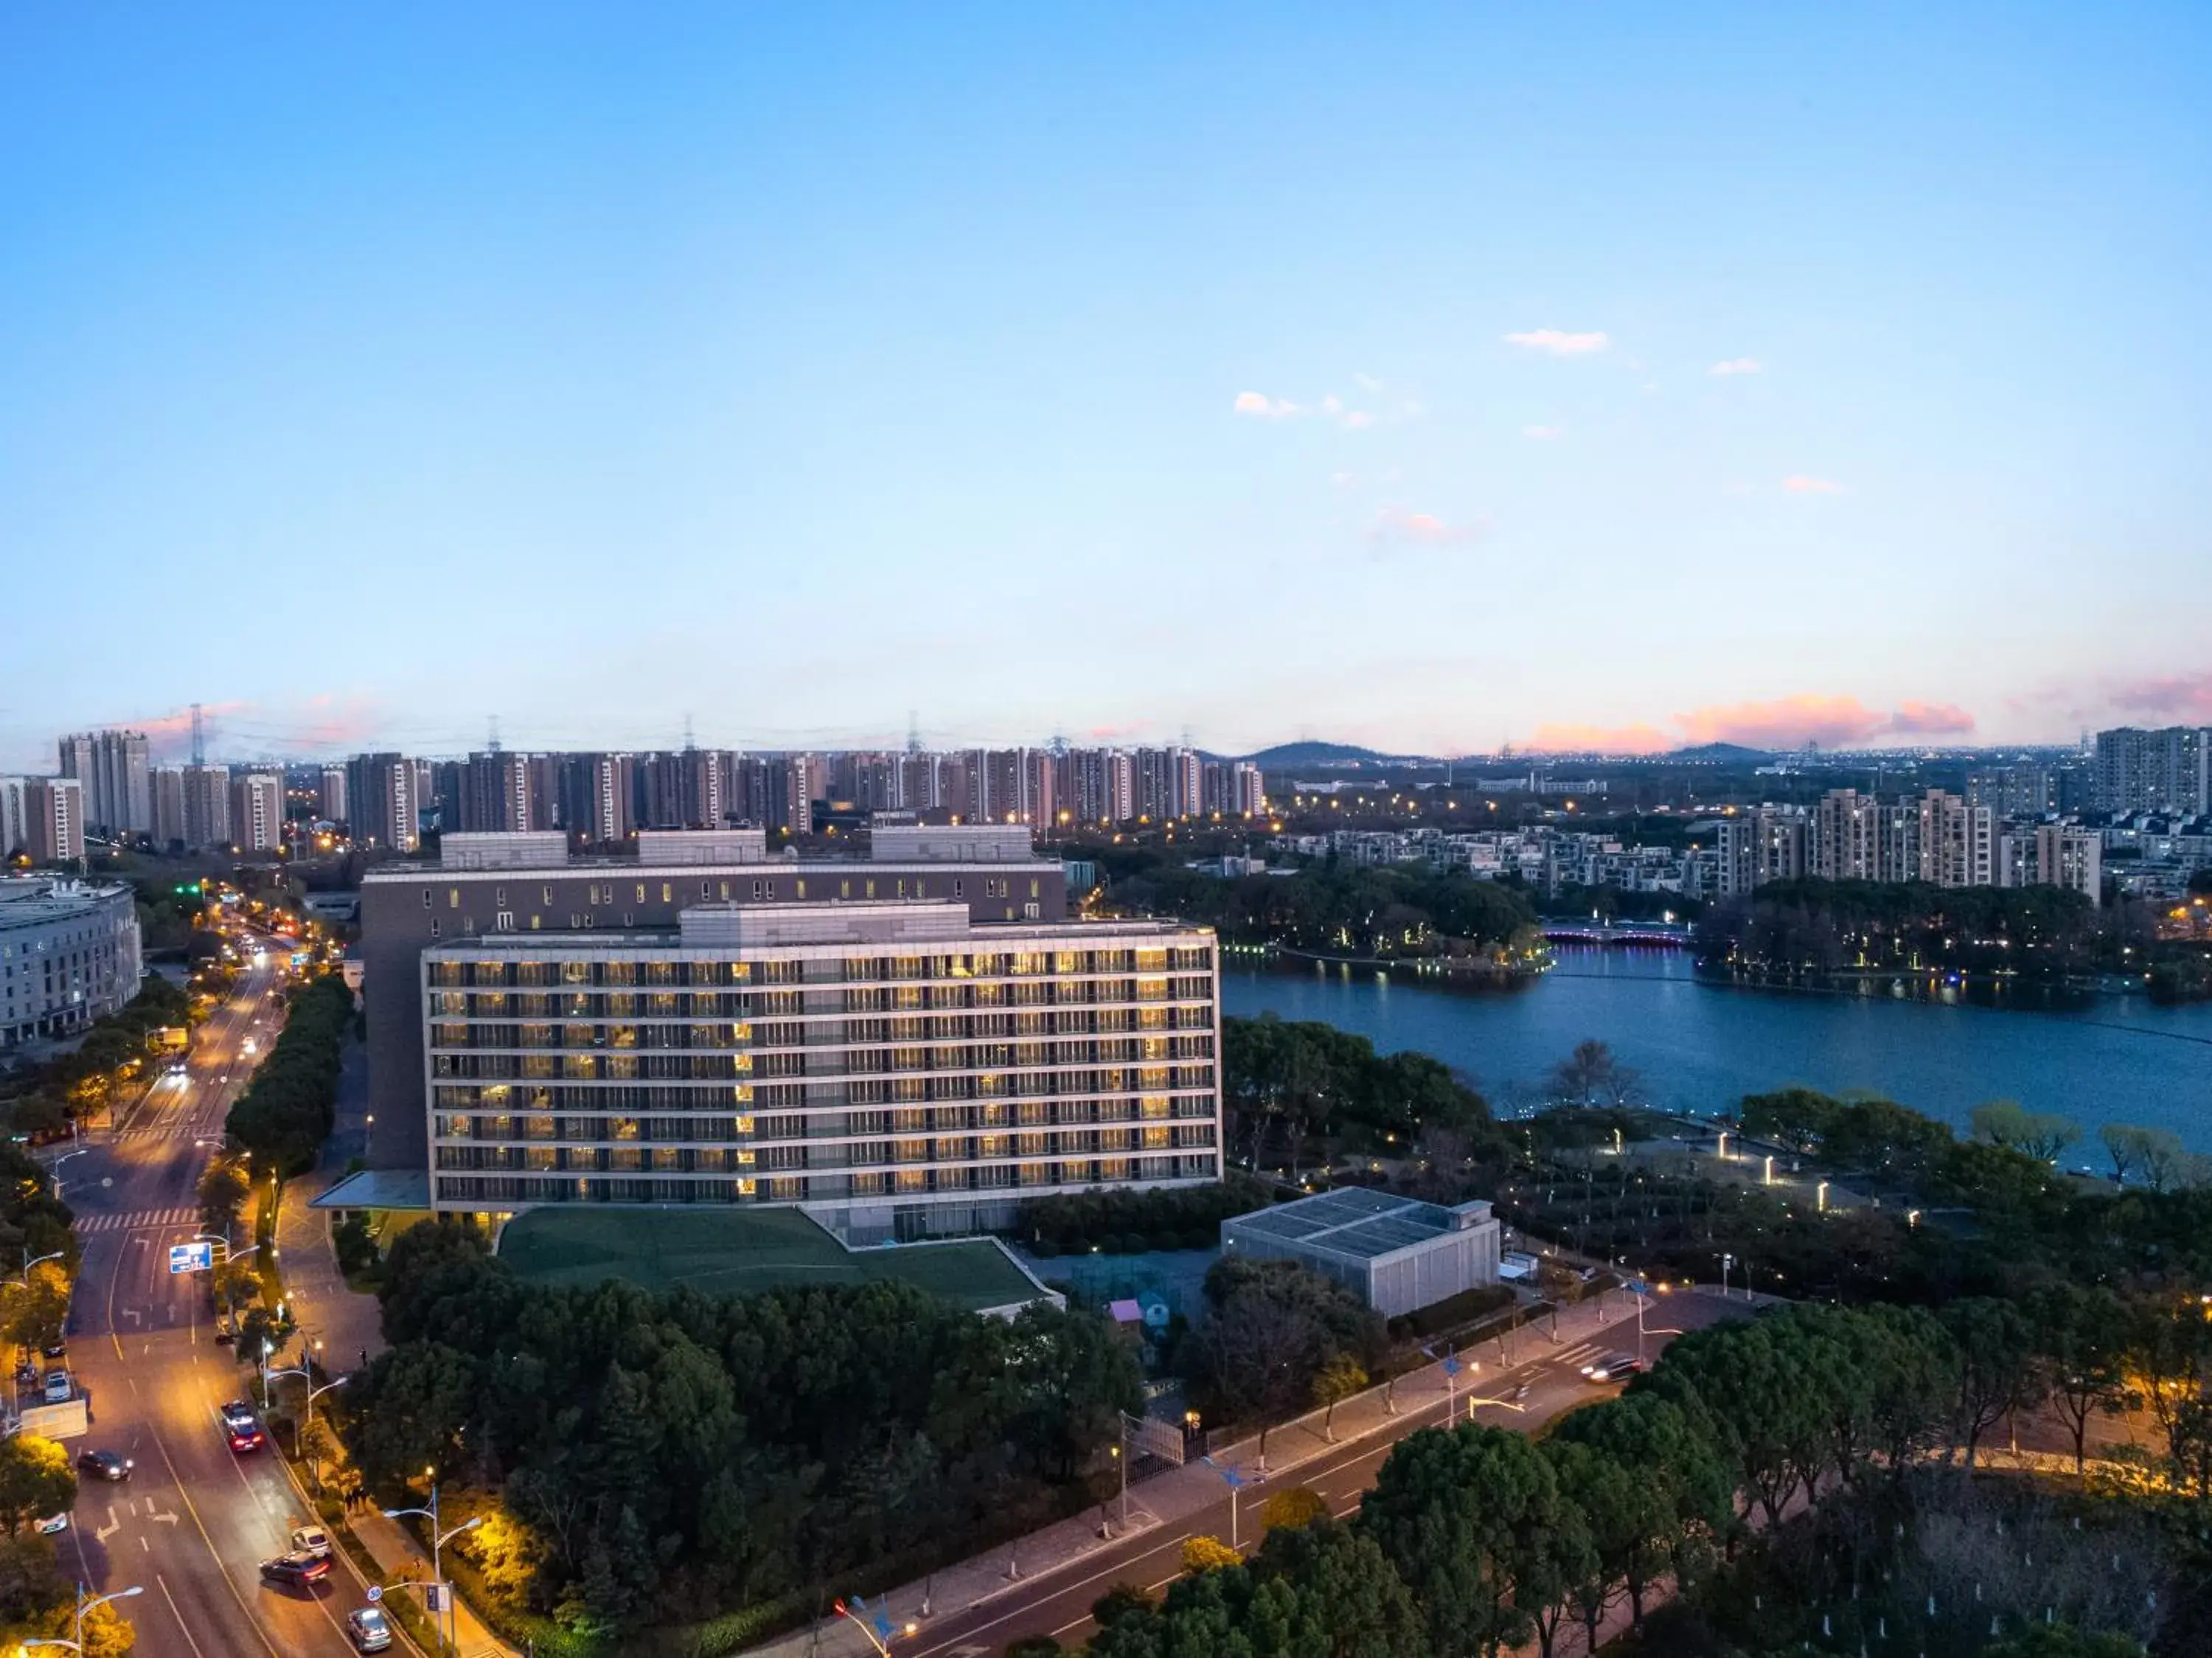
<box><xmin>363</xmin><ymin>825</ymin><xmax>1221</xmax><ymax>1242</ymax></box>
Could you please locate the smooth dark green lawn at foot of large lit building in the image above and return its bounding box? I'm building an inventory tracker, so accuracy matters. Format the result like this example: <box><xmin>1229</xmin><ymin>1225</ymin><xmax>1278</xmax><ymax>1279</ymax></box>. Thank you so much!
<box><xmin>500</xmin><ymin>1209</ymin><xmax>1037</xmax><ymax>1308</ymax></box>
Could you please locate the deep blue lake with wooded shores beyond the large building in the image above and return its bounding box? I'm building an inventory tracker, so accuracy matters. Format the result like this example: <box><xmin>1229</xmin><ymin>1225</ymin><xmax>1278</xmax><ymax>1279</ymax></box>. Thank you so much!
<box><xmin>1221</xmin><ymin>950</ymin><xmax>2212</xmax><ymax>1165</ymax></box>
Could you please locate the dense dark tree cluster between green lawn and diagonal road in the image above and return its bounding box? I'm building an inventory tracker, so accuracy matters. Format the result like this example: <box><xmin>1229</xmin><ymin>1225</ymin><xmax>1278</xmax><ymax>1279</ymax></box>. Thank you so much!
<box><xmin>347</xmin><ymin>1220</ymin><xmax>1144</xmax><ymax>1636</ymax></box>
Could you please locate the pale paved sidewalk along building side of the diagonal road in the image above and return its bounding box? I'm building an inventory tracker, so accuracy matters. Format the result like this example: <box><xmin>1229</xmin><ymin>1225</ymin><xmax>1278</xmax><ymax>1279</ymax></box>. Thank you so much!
<box><xmin>745</xmin><ymin>1300</ymin><xmax>1672</xmax><ymax>1658</ymax></box>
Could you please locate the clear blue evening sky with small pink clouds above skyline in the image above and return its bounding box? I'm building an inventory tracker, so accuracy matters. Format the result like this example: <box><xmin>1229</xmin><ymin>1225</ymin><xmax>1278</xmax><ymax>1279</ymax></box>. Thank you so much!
<box><xmin>0</xmin><ymin>4</ymin><xmax>2212</xmax><ymax>766</ymax></box>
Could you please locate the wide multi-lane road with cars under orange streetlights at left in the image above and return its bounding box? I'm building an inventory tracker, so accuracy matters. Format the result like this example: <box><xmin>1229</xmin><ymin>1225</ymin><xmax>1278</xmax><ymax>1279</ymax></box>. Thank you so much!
<box><xmin>55</xmin><ymin>937</ymin><xmax>376</xmax><ymax>1658</ymax></box>
